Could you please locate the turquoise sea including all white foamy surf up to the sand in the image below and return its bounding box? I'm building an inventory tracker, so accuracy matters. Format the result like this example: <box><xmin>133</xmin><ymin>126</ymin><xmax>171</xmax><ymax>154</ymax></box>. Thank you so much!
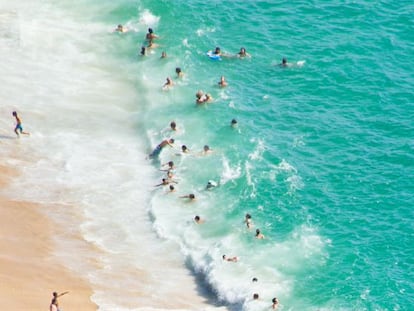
<box><xmin>0</xmin><ymin>0</ymin><xmax>414</xmax><ymax>310</ymax></box>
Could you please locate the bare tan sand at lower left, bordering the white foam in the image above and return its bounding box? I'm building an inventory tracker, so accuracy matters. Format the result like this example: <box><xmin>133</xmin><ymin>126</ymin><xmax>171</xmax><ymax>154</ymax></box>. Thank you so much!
<box><xmin>0</xmin><ymin>166</ymin><xmax>97</xmax><ymax>311</ymax></box>
